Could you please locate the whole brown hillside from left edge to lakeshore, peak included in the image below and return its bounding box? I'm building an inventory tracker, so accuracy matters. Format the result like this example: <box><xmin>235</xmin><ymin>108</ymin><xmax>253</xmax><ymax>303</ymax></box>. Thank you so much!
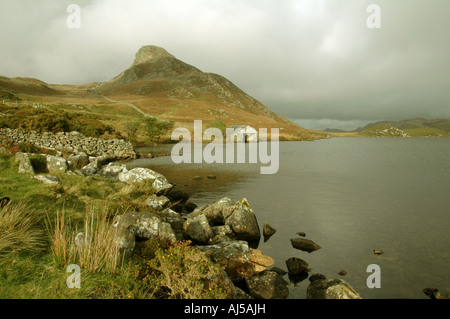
<box><xmin>0</xmin><ymin>46</ymin><xmax>327</xmax><ymax>140</ymax></box>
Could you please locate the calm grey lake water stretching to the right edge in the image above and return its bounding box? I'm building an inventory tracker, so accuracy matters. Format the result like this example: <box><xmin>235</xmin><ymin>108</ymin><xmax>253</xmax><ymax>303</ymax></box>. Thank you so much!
<box><xmin>130</xmin><ymin>138</ymin><xmax>450</xmax><ymax>298</ymax></box>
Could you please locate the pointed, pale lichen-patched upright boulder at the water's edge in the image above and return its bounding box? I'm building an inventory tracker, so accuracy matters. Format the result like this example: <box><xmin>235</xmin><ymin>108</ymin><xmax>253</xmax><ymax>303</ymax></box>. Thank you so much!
<box><xmin>223</xmin><ymin>198</ymin><xmax>261</xmax><ymax>241</ymax></box>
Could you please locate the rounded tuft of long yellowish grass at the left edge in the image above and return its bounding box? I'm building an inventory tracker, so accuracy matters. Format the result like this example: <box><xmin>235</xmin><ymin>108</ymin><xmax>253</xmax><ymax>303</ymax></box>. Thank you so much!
<box><xmin>0</xmin><ymin>202</ymin><xmax>45</xmax><ymax>255</ymax></box>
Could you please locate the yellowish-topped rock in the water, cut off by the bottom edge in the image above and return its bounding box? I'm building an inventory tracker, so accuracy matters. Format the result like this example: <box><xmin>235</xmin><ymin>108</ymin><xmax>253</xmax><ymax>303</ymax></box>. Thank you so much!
<box><xmin>306</xmin><ymin>279</ymin><xmax>362</xmax><ymax>299</ymax></box>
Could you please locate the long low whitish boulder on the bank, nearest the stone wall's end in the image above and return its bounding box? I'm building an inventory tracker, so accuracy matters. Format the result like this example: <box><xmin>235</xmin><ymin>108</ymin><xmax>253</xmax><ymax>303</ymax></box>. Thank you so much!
<box><xmin>118</xmin><ymin>167</ymin><xmax>173</xmax><ymax>194</ymax></box>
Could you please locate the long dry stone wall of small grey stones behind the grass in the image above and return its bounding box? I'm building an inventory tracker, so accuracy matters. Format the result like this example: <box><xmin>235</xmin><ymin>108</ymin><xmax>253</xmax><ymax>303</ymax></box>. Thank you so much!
<box><xmin>0</xmin><ymin>128</ymin><xmax>136</xmax><ymax>159</ymax></box>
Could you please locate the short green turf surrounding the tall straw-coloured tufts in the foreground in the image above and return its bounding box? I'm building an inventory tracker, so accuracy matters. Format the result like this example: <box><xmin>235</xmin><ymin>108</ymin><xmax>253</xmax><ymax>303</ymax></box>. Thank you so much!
<box><xmin>0</xmin><ymin>156</ymin><xmax>154</xmax><ymax>299</ymax></box>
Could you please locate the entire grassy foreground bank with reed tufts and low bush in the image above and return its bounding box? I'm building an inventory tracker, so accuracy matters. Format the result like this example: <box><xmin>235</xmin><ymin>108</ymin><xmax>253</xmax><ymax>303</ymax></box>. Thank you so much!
<box><xmin>0</xmin><ymin>155</ymin><xmax>227</xmax><ymax>299</ymax></box>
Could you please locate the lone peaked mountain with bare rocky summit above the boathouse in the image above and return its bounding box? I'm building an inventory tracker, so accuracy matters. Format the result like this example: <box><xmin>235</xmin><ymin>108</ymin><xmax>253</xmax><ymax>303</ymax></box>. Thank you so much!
<box><xmin>92</xmin><ymin>46</ymin><xmax>308</xmax><ymax>132</ymax></box>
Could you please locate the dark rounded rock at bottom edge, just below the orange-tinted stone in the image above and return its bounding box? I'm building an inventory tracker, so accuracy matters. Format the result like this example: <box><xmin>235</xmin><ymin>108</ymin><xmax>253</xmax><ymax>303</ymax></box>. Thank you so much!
<box><xmin>245</xmin><ymin>270</ymin><xmax>289</xmax><ymax>299</ymax></box>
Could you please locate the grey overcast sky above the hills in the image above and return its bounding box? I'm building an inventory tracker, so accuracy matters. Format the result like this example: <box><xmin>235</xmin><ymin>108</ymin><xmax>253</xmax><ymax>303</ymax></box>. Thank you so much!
<box><xmin>0</xmin><ymin>0</ymin><xmax>450</xmax><ymax>129</ymax></box>
